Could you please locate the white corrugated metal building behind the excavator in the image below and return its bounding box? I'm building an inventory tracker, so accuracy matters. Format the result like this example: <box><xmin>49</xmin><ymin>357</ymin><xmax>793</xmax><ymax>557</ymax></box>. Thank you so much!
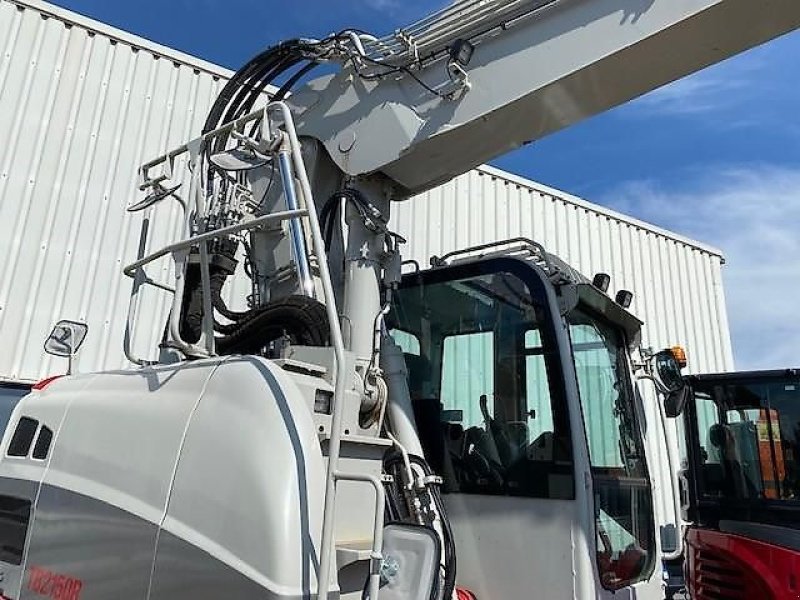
<box><xmin>0</xmin><ymin>0</ymin><xmax>733</xmax><ymax>548</ymax></box>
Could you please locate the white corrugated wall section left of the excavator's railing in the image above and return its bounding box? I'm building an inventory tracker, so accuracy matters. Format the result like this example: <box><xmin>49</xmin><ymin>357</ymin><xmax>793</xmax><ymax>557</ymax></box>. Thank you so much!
<box><xmin>0</xmin><ymin>0</ymin><xmax>229</xmax><ymax>380</ymax></box>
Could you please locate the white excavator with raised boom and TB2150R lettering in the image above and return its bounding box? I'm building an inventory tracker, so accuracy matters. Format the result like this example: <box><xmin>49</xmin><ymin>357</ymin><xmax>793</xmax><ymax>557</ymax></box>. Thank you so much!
<box><xmin>0</xmin><ymin>0</ymin><xmax>800</xmax><ymax>600</ymax></box>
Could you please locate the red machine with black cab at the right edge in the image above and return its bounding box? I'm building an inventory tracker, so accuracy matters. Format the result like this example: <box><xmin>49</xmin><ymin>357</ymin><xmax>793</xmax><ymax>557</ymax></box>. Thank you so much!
<box><xmin>666</xmin><ymin>369</ymin><xmax>800</xmax><ymax>600</ymax></box>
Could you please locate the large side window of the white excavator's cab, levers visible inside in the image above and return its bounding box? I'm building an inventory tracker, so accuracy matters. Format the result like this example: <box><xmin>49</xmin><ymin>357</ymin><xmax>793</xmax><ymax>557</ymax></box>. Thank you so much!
<box><xmin>389</xmin><ymin>272</ymin><xmax>574</xmax><ymax>498</ymax></box>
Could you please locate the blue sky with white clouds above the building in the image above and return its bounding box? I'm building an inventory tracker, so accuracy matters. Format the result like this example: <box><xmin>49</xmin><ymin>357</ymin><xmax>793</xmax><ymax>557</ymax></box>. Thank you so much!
<box><xmin>48</xmin><ymin>0</ymin><xmax>800</xmax><ymax>368</ymax></box>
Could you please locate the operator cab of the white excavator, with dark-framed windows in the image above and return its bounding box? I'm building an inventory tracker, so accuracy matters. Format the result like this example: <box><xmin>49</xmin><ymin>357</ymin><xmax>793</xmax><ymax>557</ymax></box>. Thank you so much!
<box><xmin>389</xmin><ymin>247</ymin><xmax>656</xmax><ymax>597</ymax></box>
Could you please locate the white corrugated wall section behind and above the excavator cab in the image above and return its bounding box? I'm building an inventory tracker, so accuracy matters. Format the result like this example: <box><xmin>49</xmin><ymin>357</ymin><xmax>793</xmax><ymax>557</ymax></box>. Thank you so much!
<box><xmin>392</xmin><ymin>167</ymin><xmax>734</xmax><ymax>548</ymax></box>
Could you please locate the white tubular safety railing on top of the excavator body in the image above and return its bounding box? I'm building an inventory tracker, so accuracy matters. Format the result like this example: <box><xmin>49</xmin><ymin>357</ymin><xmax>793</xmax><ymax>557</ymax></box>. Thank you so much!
<box><xmin>123</xmin><ymin>102</ymin><xmax>354</xmax><ymax>600</ymax></box>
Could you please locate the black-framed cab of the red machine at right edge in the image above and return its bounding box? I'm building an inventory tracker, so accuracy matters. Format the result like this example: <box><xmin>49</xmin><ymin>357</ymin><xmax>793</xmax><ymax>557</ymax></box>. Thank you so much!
<box><xmin>684</xmin><ymin>370</ymin><xmax>800</xmax><ymax>529</ymax></box>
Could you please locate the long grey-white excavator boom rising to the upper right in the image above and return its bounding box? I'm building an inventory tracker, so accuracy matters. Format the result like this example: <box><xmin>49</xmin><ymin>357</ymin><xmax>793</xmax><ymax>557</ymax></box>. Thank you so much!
<box><xmin>293</xmin><ymin>0</ymin><xmax>800</xmax><ymax>193</ymax></box>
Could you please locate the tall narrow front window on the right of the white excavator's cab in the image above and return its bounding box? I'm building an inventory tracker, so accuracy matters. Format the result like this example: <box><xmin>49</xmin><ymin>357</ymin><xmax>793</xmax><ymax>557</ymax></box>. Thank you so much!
<box><xmin>568</xmin><ymin>310</ymin><xmax>655</xmax><ymax>589</ymax></box>
